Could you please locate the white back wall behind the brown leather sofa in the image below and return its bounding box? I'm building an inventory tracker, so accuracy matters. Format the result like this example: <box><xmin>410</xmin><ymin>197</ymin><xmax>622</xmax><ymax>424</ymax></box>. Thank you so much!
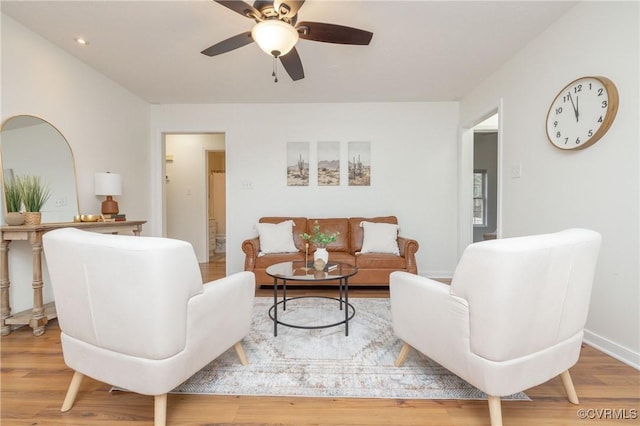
<box><xmin>151</xmin><ymin>102</ymin><xmax>458</xmax><ymax>276</ymax></box>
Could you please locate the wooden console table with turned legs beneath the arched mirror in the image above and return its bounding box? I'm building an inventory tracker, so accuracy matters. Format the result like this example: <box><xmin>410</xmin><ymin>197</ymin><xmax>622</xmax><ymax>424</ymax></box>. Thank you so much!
<box><xmin>0</xmin><ymin>220</ymin><xmax>147</xmax><ymax>336</ymax></box>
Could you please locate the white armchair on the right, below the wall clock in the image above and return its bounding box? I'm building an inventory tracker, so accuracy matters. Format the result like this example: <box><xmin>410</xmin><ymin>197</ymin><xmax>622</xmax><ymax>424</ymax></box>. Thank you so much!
<box><xmin>390</xmin><ymin>229</ymin><xmax>601</xmax><ymax>426</ymax></box>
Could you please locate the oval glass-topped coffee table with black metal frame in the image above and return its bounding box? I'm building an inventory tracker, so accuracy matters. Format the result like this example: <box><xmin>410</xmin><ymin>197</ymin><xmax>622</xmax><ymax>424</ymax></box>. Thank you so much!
<box><xmin>266</xmin><ymin>261</ymin><xmax>358</xmax><ymax>336</ymax></box>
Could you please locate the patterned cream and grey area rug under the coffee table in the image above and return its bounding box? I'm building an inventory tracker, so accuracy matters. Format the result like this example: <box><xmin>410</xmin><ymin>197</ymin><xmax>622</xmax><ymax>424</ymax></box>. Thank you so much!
<box><xmin>173</xmin><ymin>297</ymin><xmax>529</xmax><ymax>400</ymax></box>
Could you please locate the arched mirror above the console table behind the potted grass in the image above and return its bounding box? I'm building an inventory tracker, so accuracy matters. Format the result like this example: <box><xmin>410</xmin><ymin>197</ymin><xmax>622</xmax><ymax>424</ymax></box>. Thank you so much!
<box><xmin>0</xmin><ymin>115</ymin><xmax>78</xmax><ymax>223</ymax></box>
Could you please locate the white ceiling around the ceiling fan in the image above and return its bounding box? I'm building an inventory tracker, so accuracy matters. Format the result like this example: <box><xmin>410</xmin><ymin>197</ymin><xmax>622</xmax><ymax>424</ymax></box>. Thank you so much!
<box><xmin>0</xmin><ymin>0</ymin><xmax>576</xmax><ymax>104</ymax></box>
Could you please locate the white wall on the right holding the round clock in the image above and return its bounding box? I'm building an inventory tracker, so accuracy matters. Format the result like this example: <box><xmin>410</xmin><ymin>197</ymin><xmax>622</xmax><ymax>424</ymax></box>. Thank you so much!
<box><xmin>460</xmin><ymin>2</ymin><xmax>640</xmax><ymax>367</ymax></box>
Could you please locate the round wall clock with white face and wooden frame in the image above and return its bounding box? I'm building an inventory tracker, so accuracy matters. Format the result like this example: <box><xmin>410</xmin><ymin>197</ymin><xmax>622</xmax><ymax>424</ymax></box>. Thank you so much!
<box><xmin>547</xmin><ymin>77</ymin><xmax>618</xmax><ymax>150</ymax></box>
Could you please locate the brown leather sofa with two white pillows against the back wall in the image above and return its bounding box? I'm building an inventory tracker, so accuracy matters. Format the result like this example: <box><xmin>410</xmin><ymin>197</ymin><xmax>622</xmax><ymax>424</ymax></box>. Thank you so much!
<box><xmin>242</xmin><ymin>216</ymin><xmax>418</xmax><ymax>286</ymax></box>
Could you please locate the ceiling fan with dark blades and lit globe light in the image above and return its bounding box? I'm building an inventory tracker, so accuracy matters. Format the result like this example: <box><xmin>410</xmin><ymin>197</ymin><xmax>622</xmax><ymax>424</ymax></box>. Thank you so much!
<box><xmin>201</xmin><ymin>0</ymin><xmax>373</xmax><ymax>82</ymax></box>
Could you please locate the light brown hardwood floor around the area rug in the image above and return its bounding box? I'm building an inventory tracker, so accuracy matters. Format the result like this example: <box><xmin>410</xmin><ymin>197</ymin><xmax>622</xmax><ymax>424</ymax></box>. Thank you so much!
<box><xmin>0</xmin><ymin>262</ymin><xmax>640</xmax><ymax>426</ymax></box>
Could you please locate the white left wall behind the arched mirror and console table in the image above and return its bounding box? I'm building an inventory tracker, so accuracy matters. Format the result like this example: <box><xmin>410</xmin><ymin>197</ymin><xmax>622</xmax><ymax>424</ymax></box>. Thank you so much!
<box><xmin>0</xmin><ymin>15</ymin><xmax>150</xmax><ymax>313</ymax></box>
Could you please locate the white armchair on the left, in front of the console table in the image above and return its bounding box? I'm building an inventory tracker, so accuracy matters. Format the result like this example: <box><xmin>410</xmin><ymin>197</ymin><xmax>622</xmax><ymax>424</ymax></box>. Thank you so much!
<box><xmin>43</xmin><ymin>228</ymin><xmax>255</xmax><ymax>426</ymax></box>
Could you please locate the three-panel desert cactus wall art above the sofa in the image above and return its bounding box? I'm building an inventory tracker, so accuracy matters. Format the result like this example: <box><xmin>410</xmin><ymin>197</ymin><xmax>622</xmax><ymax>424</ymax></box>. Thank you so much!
<box><xmin>287</xmin><ymin>141</ymin><xmax>371</xmax><ymax>186</ymax></box>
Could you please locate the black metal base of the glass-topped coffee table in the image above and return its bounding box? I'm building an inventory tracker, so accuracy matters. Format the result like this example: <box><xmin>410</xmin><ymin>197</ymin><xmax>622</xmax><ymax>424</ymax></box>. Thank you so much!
<box><xmin>269</xmin><ymin>278</ymin><xmax>356</xmax><ymax>336</ymax></box>
